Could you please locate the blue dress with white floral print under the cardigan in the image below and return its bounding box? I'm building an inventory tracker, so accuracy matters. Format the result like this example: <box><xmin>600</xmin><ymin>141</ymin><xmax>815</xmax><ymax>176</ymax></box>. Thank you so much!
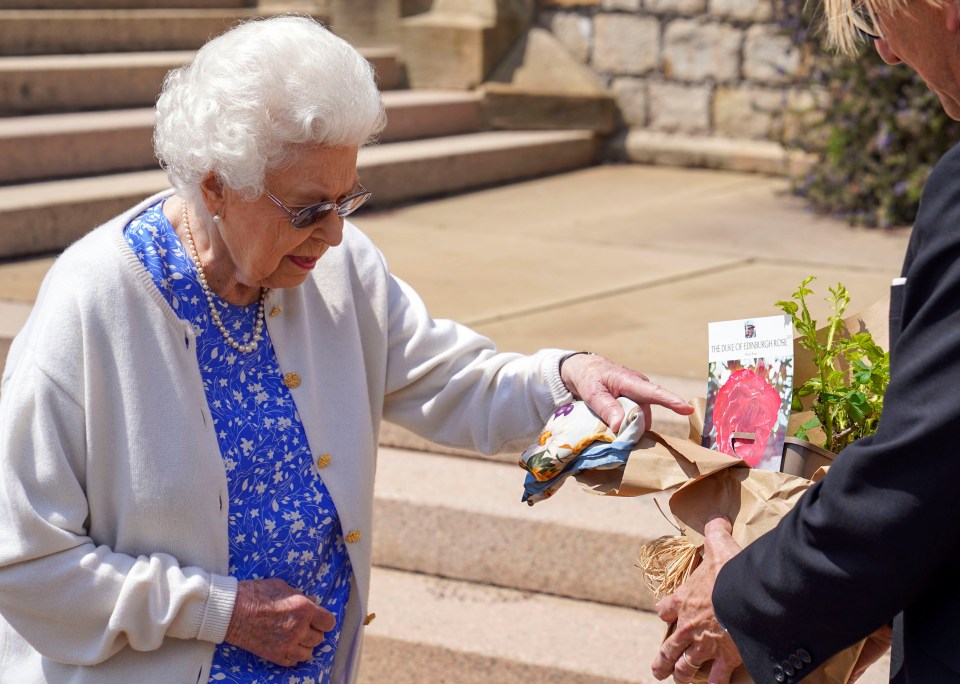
<box><xmin>124</xmin><ymin>201</ymin><xmax>351</xmax><ymax>684</ymax></box>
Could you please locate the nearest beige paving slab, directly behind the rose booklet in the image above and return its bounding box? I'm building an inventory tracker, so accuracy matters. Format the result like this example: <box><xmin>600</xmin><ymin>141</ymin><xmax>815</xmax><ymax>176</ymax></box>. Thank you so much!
<box><xmin>472</xmin><ymin>262</ymin><xmax>897</xmax><ymax>379</ymax></box>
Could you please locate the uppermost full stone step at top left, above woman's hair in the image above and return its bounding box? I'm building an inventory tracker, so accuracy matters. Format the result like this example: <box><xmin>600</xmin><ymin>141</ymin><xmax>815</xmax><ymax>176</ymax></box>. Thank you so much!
<box><xmin>0</xmin><ymin>8</ymin><xmax>270</xmax><ymax>55</ymax></box>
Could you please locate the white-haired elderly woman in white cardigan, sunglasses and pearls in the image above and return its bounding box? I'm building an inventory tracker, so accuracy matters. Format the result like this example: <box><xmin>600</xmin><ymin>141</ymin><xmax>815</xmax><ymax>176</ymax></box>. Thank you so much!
<box><xmin>0</xmin><ymin>17</ymin><xmax>686</xmax><ymax>684</ymax></box>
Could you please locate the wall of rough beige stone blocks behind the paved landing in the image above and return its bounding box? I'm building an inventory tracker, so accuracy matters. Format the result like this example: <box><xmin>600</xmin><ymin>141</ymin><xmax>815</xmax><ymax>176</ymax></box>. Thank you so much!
<box><xmin>537</xmin><ymin>0</ymin><xmax>813</xmax><ymax>140</ymax></box>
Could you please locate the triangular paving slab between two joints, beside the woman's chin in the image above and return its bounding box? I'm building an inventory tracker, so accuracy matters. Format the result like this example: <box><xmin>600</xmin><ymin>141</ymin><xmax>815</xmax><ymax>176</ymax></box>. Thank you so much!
<box><xmin>357</xmin><ymin>220</ymin><xmax>744</xmax><ymax>325</ymax></box>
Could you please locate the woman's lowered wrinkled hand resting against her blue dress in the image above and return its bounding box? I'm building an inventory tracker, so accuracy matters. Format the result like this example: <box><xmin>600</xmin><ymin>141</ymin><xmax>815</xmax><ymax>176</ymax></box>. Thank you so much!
<box><xmin>224</xmin><ymin>579</ymin><xmax>336</xmax><ymax>667</ymax></box>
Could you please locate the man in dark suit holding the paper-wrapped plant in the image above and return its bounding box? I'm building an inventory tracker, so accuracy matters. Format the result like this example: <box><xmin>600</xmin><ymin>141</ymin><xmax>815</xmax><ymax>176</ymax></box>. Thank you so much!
<box><xmin>653</xmin><ymin>0</ymin><xmax>960</xmax><ymax>684</ymax></box>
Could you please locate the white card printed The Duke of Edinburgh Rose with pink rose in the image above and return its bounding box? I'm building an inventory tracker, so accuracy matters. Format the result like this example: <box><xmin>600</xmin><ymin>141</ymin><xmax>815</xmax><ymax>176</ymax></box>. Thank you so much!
<box><xmin>702</xmin><ymin>316</ymin><xmax>793</xmax><ymax>470</ymax></box>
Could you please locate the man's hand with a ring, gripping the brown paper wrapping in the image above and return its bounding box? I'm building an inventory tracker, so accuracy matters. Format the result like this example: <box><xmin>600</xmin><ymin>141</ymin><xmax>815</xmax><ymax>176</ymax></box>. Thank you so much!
<box><xmin>653</xmin><ymin>517</ymin><xmax>743</xmax><ymax>684</ymax></box>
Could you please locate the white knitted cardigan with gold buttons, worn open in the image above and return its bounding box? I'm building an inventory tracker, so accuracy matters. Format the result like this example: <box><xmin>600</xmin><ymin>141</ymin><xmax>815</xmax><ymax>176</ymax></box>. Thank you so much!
<box><xmin>0</xmin><ymin>193</ymin><xmax>571</xmax><ymax>684</ymax></box>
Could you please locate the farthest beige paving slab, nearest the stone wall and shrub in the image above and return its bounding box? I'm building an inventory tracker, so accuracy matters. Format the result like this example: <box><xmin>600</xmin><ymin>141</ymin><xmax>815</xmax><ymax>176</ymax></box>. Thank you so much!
<box><xmin>358</xmin><ymin>164</ymin><xmax>909</xmax><ymax>269</ymax></box>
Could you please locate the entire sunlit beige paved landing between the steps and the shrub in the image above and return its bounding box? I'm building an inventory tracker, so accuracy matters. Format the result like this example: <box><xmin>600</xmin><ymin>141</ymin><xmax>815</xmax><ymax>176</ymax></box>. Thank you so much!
<box><xmin>357</xmin><ymin>166</ymin><xmax>909</xmax><ymax>379</ymax></box>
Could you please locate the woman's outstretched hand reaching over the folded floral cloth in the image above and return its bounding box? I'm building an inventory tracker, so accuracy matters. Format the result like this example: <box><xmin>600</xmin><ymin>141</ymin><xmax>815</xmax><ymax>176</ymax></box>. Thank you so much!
<box><xmin>560</xmin><ymin>354</ymin><xmax>693</xmax><ymax>432</ymax></box>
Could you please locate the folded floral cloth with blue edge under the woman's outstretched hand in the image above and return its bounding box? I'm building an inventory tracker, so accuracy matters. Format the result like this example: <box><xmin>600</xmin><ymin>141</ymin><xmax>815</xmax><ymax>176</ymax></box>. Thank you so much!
<box><xmin>520</xmin><ymin>397</ymin><xmax>646</xmax><ymax>506</ymax></box>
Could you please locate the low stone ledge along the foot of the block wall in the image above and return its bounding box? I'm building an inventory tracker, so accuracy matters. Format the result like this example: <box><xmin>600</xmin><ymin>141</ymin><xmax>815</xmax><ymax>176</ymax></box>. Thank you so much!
<box><xmin>606</xmin><ymin>129</ymin><xmax>810</xmax><ymax>176</ymax></box>
